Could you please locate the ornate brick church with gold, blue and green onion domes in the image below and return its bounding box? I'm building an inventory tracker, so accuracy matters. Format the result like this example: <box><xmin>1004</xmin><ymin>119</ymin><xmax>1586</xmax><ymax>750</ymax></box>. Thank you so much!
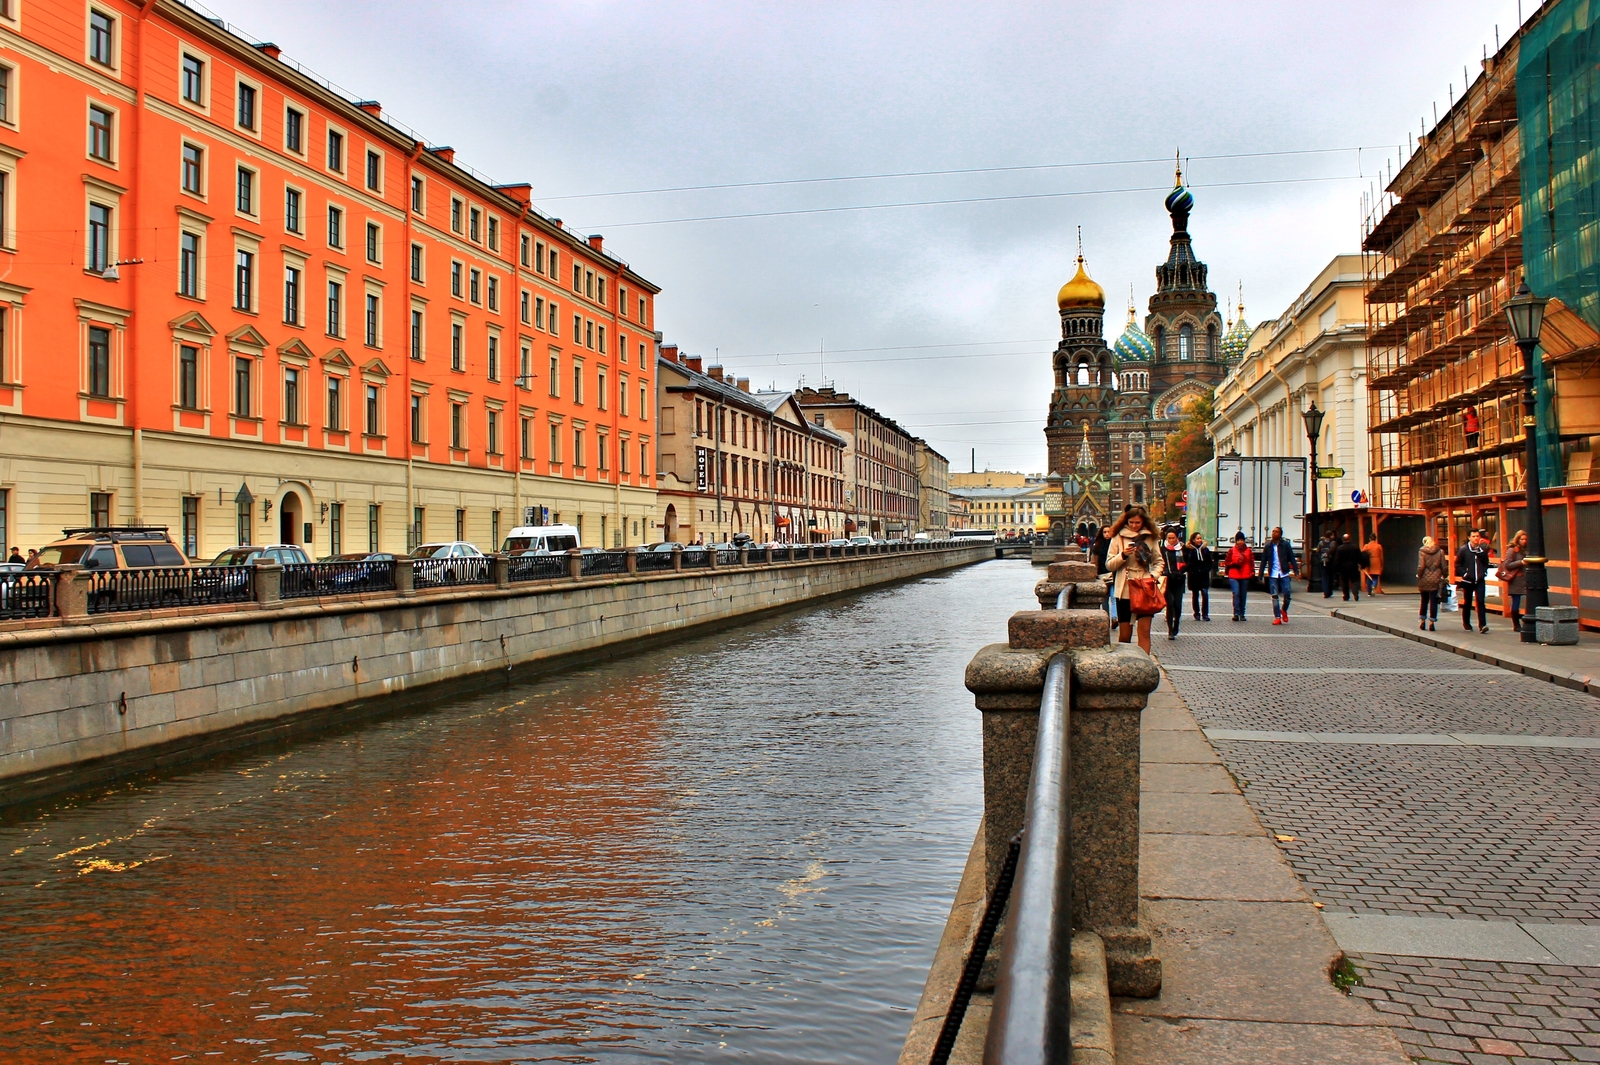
<box><xmin>1045</xmin><ymin>171</ymin><xmax>1250</xmax><ymax>537</ymax></box>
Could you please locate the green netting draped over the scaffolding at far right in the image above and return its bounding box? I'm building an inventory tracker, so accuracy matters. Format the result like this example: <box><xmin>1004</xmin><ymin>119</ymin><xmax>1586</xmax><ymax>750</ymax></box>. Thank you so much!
<box><xmin>1517</xmin><ymin>0</ymin><xmax>1600</xmax><ymax>485</ymax></box>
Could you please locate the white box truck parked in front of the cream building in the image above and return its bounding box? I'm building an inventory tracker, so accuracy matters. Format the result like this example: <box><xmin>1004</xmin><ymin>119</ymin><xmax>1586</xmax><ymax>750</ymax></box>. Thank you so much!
<box><xmin>1186</xmin><ymin>454</ymin><xmax>1306</xmax><ymax>558</ymax></box>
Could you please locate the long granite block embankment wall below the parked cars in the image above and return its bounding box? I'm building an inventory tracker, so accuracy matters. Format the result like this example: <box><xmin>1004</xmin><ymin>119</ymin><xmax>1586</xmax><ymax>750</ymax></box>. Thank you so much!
<box><xmin>0</xmin><ymin>545</ymin><xmax>994</xmax><ymax>803</ymax></box>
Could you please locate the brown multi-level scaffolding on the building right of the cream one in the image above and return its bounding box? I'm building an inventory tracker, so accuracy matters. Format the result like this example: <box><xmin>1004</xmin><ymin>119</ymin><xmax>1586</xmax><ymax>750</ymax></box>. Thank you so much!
<box><xmin>1362</xmin><ymin>34</ymin><xmax>1523</xmax><ymax>507</ymax></box>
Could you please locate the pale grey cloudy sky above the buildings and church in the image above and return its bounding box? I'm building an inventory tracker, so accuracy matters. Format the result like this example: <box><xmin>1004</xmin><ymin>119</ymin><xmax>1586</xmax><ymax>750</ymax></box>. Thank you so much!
<box><xmin>208</xmin><ymin>0</ymin><xmax>1536</xmax><ymax>472</ymax></box>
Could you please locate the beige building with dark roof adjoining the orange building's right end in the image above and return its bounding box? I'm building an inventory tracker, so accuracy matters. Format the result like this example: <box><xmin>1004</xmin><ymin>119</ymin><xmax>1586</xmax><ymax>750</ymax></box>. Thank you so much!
<box><xmin>656</xmin><ymin>344</ymin><xmax>845</xmax><ymax>544</ymax></box>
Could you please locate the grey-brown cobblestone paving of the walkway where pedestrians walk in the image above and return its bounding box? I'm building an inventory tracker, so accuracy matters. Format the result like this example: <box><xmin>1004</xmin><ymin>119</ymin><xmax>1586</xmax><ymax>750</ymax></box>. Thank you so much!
<box><xmin>1155</xmin><ymin>600</ymin><xmax>1600</xmax><ymax>1065</ymax></box>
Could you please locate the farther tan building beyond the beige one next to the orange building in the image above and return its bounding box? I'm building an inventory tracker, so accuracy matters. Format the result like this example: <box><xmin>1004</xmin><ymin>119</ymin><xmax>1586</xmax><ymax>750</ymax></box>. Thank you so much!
<box><xmin>795</xmin><ymin>389</ymin><xmax>917</xmax><ymax>539</ymax></box>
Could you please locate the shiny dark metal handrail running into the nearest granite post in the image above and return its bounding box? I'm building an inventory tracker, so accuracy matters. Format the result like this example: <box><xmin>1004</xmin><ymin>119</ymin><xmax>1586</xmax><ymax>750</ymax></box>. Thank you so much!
<box><xmin>984</xmin><ymin>656</ymin><xmax>1072</xmax><ymax>1065</ymax></box>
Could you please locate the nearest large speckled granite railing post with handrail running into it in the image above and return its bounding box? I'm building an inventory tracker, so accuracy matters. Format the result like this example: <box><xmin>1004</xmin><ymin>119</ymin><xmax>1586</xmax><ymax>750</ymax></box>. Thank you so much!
<box><xmin>966</xmin><ymin>598</ymin><xmax>1162</xmax><ymax>998</ymax></box>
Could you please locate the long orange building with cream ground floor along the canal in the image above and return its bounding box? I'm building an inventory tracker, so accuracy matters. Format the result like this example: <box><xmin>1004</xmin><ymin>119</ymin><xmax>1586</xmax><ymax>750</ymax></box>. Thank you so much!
<box><xmin>0</xmin><ymin>0</ymin><xmax>659</xmax><ymax>556</ymax></box>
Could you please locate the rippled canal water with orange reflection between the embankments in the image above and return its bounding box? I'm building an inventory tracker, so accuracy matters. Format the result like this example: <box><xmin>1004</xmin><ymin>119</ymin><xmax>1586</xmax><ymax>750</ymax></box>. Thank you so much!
<box><xmin>0</xmin><ymin>561</ymin><xmax>1038</xmax><ymax>1063</ymax></box>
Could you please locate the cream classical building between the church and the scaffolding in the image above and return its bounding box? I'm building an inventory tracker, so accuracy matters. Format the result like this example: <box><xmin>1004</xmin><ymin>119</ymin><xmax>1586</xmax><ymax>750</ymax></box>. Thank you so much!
<box><xmin>1208</xmin><ymin>254</ymin><xmax>1371</xmax><ymax>510</ymax></box>
